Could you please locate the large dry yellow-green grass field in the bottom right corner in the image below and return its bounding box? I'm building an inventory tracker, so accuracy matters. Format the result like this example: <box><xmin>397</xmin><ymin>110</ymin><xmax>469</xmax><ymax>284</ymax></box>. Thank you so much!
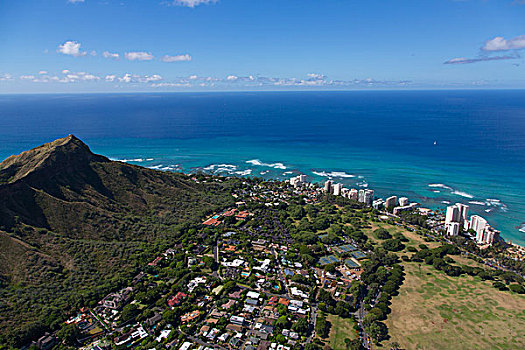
<box><xmin>384</xmin><ymin>263</ymin><xmax>525</xmax><ymax>349</ymax></box>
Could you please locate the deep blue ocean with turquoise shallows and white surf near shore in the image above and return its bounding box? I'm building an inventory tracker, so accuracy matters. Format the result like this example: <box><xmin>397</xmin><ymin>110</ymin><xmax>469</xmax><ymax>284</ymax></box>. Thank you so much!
<box><xmin>0</xmin><ymin>90</ymin><xmax>525</xmax><ymax>245</ymax></box>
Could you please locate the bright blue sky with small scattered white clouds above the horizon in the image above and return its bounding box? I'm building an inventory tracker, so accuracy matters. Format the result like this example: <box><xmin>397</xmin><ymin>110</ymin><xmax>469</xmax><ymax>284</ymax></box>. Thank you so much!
<box><xmin>0</xmin><ymin>0</ymin><xmax>525</xmax><ymax>93</ymax></box>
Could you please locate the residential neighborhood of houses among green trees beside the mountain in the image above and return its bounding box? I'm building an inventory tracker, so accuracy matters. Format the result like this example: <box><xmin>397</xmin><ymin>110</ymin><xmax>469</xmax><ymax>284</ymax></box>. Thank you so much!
<box><xmin>28</xmin><ymin>176</ymin><xmax>524</xmax><ymax>350</ymax></box>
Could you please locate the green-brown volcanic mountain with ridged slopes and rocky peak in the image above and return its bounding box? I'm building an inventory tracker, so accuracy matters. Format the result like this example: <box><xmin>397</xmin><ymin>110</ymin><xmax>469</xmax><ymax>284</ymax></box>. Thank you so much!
<box><xmin>0</xmin><ymin>135</ymin><xmax>238</xmax><ymax>340</ymax></box>
